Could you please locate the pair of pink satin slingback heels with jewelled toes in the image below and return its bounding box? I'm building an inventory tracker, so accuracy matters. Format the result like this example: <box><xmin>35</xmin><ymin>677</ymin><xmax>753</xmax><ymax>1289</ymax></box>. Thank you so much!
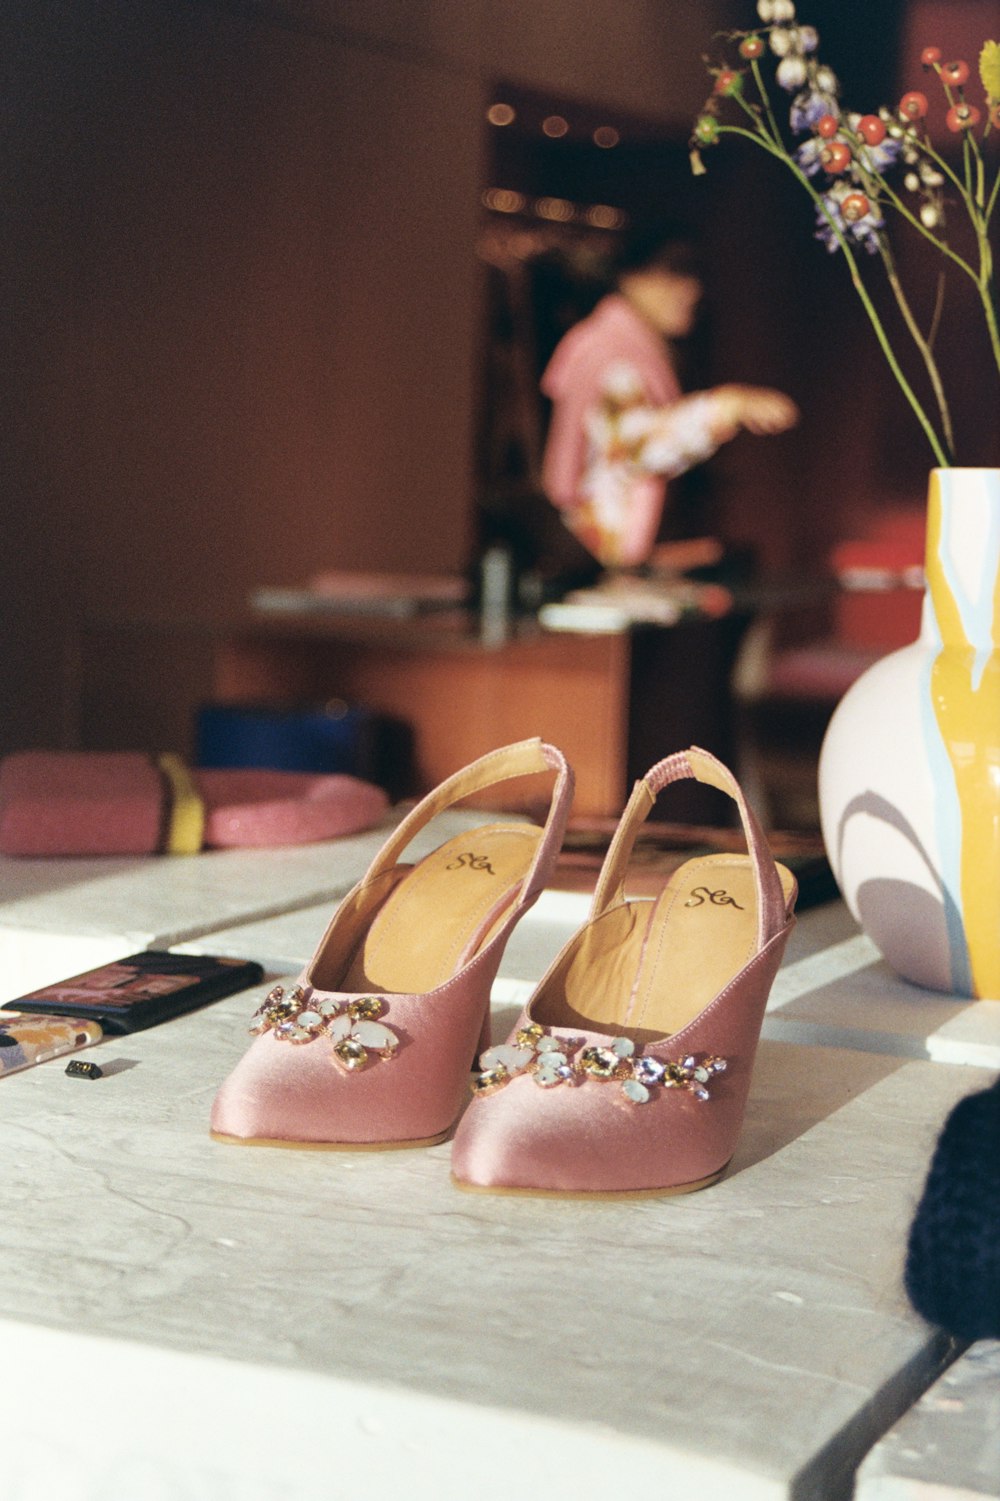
<box><xmin>212</xmin><ymin>740</ymin><xmax>796</xmax><ymax>1195</ymax></box>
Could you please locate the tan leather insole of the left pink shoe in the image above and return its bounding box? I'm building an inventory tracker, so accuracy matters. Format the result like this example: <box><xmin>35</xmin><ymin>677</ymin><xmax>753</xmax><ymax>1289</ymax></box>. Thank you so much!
<box><xmin>341</xmin><ymin>824</ymin><xmax>542</xmax><ymax>994</ymax></box>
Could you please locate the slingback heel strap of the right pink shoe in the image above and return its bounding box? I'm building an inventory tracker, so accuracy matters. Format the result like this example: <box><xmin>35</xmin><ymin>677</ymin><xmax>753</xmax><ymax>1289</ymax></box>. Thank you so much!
<box><xmin>592</xmin><ymin>746</ymin><xmax>788</xmax><ymax>949</ymax></box>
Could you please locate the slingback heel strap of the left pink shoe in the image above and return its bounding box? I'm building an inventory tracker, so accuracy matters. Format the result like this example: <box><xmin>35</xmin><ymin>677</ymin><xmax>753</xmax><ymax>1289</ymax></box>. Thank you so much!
<box><xmin>365</xmin><ymin>738</ymin><xmax>574</xmax><ymax>910</ymax></box>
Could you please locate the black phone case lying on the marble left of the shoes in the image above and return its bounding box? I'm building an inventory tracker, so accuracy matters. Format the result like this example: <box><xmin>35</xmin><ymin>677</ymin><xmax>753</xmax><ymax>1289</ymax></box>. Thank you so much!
<box><xmin>0</xmin><ymin>949</ymin><xmax>264</xmax><ymax>1036</ymax></box>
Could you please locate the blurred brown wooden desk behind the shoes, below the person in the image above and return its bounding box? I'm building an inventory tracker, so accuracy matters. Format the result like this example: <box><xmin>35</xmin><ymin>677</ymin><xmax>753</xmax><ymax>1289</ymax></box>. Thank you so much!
<box><xmin>80</xmin><ymin>611</ymin><xmax>746</xmax><ymax>823</ymax></box>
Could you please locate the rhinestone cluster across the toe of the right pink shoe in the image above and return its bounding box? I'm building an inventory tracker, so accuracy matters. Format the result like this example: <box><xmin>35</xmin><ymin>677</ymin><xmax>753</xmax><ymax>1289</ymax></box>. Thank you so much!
<box><xmin>471</xmin><ymin>1022</ymin><xmax>727</xmax><ymax>1105</ymax></box>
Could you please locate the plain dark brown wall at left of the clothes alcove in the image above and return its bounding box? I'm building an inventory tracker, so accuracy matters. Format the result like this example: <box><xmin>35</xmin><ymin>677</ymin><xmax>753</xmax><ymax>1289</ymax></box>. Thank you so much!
<box><xmin>0</xmin><ymin>0</ymin><xmax>482</xmax><ymax>744</ymax></box>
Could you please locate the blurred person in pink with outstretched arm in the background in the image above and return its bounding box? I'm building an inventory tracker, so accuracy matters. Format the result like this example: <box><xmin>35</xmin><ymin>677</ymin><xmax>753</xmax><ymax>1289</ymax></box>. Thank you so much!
<box><xmin>542</xmin><ymin>228</ymin><xmax>799</xmax><ymax>567</ymax></box>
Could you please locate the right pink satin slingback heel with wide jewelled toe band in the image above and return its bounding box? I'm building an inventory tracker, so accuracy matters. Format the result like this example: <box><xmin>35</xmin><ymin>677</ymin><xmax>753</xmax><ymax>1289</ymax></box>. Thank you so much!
<box><xmin>452</xmin><ymin>746</ymin><xmax>796</xmax><ymax>1196</ymax></box>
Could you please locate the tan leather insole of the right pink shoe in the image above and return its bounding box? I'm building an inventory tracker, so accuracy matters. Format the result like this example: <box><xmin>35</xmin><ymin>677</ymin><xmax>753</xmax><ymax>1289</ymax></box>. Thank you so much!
<box><xmin>535</xmin><ymin>854</ymin><xmax>794</xmax><ymax>1042</ymax></box>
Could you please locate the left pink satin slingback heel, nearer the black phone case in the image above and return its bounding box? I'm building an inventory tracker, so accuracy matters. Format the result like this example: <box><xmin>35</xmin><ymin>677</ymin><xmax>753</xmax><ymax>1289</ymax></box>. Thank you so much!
<box><xmin>212</xmin><ymin>740</ymin><xmax>574</xmax><ymax>1148</ymax></box>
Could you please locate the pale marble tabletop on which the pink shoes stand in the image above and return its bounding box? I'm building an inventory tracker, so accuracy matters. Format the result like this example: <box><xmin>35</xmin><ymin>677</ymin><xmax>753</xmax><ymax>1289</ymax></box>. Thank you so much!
<box><xmin>0</xmin><ymin>834</ymin><xmax>992</xmax><ymax>1501</ymax></box>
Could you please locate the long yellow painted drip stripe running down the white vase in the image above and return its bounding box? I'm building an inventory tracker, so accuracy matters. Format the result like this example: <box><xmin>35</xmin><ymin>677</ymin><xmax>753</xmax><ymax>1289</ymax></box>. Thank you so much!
<box><xmin>926</xmin><ymin>471</ymin><xmax>1000</xmax><ymax>1000</ymax></box>
